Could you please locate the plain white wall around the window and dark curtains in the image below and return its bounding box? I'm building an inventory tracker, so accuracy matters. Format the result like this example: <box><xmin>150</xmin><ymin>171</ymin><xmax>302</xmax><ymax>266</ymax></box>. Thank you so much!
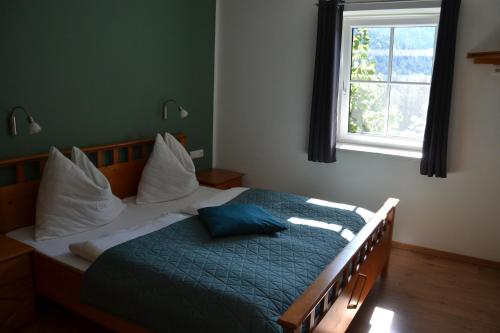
<box><xmin>215</xmin><ymin>0</ymin><xmax>500</xmax><ymax>261</ymax></box>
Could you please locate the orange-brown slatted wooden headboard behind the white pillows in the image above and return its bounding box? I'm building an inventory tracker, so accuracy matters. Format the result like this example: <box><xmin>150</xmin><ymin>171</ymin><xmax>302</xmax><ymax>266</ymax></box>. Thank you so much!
<box><xmin>0</xmin><ymin>133</ymin><xmax>186</xmax><ymax>234</ymax></box>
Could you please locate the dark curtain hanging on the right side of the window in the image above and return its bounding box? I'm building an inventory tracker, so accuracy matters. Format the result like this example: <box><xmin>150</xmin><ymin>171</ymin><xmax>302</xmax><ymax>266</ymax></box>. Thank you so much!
<box><xmin>420</xmin><ymin>0</ymin><xmax>460</xmax><ymax>178</ymax></box>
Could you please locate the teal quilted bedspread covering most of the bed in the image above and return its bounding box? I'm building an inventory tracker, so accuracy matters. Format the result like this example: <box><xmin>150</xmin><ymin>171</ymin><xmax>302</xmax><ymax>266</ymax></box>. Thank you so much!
<box><xmin>81</xmin><ymin>189</ymin><xmax>365</xmax><ymax>333</ymax></box>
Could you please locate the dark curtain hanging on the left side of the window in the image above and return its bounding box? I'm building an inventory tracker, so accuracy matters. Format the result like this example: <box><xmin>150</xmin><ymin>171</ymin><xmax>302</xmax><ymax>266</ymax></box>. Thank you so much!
<box><xmin>308</xmin><ymin>0</ymin><xmax>344</xmax><ymax>163</ymax></box>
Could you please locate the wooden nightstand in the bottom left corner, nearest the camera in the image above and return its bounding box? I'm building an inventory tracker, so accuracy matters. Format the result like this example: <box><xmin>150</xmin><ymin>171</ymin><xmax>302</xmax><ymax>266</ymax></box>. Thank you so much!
<box><xmin>0</xmin><ymin>235</ymin><xmax>35</xmax><ymax>332</ymax></box>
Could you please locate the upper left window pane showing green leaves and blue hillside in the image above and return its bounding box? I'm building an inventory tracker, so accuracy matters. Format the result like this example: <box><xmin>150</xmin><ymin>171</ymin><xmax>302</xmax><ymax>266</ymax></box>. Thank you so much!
<box><xmin>351</xmin><ymin>28</ymin><xmax>391</xmax><ymax>81</ymax></box>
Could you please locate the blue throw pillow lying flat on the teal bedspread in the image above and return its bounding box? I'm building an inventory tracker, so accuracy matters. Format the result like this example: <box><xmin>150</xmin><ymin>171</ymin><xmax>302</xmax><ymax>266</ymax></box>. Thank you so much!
<box><xmin>198</xmin><ymin>204</ymin><xmax>287</xmax><ymax>237</ymax></box>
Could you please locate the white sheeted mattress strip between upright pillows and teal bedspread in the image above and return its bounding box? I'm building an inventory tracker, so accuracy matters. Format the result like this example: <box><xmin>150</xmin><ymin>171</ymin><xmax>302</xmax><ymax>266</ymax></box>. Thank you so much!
<box><xmin>6</xmin><ymin>186</ymin><xmax>222</xmax><ymax>272</ymax></box>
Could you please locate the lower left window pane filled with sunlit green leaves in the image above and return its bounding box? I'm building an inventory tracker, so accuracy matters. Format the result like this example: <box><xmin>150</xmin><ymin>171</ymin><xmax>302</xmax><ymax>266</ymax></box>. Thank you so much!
<box><xmin>349</xmin><ymin>83</ymin><xmax>388</xmax><ymax>135</ymax></box>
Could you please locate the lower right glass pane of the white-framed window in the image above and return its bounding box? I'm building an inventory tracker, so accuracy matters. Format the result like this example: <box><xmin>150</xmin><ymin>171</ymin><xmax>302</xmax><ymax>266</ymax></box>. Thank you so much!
<box><xmin>388</xmin><ymin>84</ymin><xmax>430</xmax><ymax>140</ymax></box>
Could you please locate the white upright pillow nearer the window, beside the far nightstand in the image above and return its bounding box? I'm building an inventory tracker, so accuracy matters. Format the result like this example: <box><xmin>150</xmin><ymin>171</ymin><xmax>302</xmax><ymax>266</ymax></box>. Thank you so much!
<box><xmin>136</xmin><ymin>134</ymin><xmax>199</xmax><ymax>204</ymax></box>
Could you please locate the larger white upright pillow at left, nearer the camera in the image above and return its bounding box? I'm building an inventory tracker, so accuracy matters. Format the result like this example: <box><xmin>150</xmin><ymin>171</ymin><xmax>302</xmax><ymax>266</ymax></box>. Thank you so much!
<box><xmin>35</xmin><ymin>147</ymin><xmax>125</xmax><ymax>241</ymax></box>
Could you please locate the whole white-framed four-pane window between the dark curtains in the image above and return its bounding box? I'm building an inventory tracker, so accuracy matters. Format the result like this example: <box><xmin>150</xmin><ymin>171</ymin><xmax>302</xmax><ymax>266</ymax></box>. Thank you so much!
<box><xmin>337</xmin><ymin>9</ymin><xmax>439</xmax><ymax>156</ymax></box>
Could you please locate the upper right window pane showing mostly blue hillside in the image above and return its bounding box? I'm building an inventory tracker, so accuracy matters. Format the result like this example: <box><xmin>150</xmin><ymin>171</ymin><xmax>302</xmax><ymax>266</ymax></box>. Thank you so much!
<box><xmin>392</xmin><ymin>27</ymin><xmax>436</xmax><ymax>83</ymax></box>
